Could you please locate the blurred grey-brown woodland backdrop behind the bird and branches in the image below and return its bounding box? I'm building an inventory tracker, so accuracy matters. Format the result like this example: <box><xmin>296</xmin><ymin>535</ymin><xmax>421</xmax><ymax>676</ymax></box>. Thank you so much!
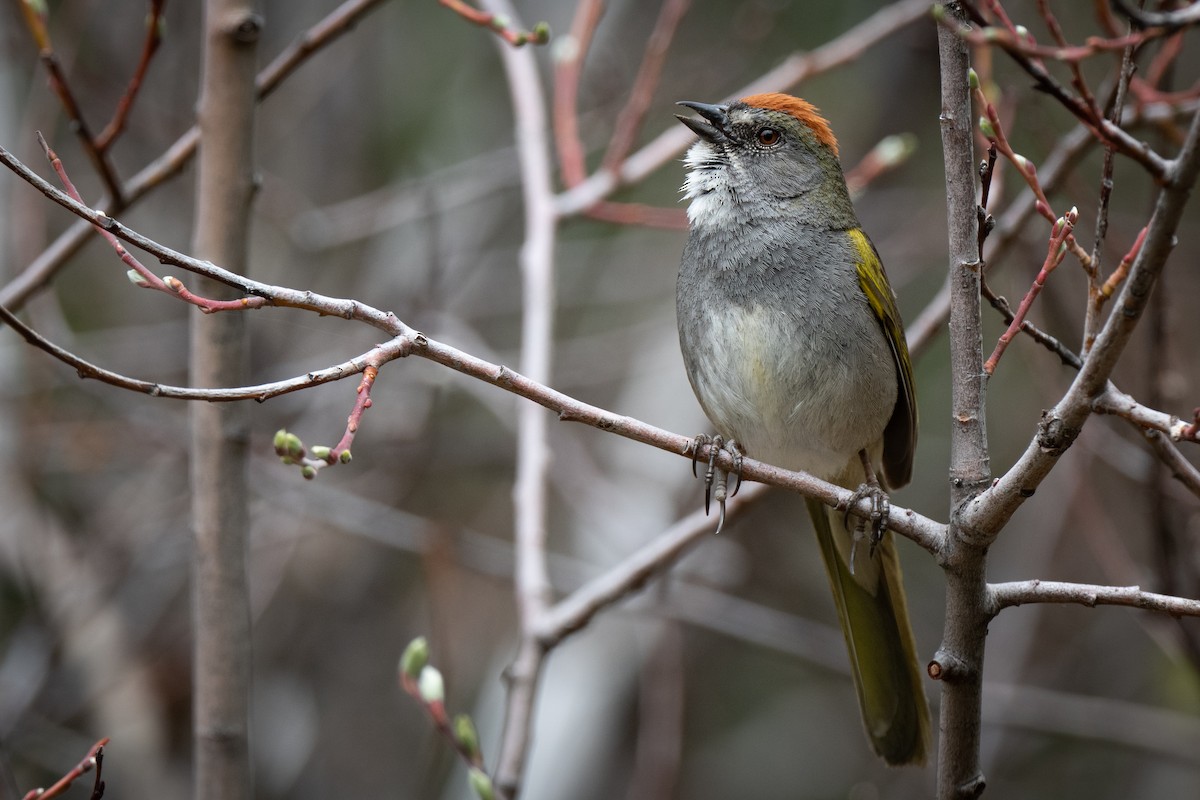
<box><xmin>0</xmin><ymin>0</ymin><xmax>1200</xmax><ymax>800</ymax></box>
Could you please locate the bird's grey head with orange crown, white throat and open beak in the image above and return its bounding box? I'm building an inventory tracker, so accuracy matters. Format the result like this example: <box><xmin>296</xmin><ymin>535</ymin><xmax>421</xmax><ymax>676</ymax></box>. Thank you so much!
<box><xmin>677</xmin><ymin>94</ymin><xmax>853</xmax><ymax>228</ymax></box>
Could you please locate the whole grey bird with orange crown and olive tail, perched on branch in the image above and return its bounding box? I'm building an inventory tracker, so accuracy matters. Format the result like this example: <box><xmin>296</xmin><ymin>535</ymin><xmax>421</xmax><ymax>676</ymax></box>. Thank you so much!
<box><xmin>677</xmin><ymin>94</ymin><xmax>930</xmax><ymax>764</ymax></box>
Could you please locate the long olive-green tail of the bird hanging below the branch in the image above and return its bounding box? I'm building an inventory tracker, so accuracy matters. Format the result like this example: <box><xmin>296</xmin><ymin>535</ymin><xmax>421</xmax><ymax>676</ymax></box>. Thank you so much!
<box><xmin>808</xmin><ymin>499</ymin><xmax>930</xmax><ymax>765</ymax></box>
